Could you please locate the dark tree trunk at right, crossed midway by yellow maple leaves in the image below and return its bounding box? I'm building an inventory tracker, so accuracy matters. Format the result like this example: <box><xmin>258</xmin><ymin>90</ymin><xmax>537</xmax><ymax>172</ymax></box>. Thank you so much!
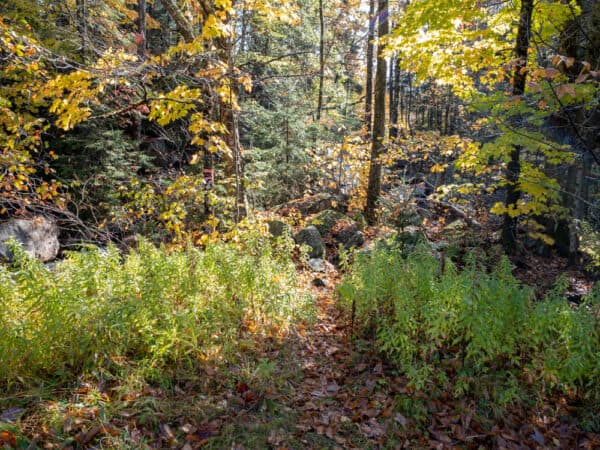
<box><xmin>502</xmin><ymin>0</ymin><xmax>533</xmax><ymax>253</ymax></box>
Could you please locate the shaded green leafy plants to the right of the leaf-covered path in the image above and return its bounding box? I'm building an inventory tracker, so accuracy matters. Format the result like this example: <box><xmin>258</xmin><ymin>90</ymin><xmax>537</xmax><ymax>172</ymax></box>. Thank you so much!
<box><xmin>339</xmin><ymin>247</ymin><xmax>600</xmax><ymax>405</ymax></box>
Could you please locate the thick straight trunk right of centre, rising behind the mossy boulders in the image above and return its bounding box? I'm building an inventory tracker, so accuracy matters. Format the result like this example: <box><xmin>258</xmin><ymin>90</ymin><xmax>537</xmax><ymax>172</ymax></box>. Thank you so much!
<box><xmin>365</xmin><ymin>0</ymin><xmax>389</xmax><ymax>224</ymax></box>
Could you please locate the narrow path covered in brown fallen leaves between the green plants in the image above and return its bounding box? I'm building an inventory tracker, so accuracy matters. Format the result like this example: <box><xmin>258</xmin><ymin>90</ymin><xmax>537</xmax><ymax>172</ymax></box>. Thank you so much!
<box><xmin>251</xmin><ymin>264</ymin><xmax>404</xmax><ymax>448</ymax></box>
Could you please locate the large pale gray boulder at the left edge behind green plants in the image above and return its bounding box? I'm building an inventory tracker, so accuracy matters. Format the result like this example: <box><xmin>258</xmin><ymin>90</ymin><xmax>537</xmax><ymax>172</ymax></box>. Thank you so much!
<box><xmin>0</xmin><ymin>217</ymin><xmax>60</xmax><ymax>262</ymax></box>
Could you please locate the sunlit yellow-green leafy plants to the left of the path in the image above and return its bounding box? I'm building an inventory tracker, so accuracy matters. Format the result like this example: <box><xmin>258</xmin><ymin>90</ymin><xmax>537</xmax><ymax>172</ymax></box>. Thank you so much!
<box><xmin>0</xmin><ymin>230</ymin><xmax>309</xmax><ymax>389</ymax></box>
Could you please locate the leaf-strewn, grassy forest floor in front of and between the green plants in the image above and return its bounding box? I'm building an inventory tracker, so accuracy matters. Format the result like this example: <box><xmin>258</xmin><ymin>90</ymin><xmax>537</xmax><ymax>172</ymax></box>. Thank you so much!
<box><xmin>5</xmin><ymin>250</ymin><xmax>600</xmax><ymax>450</ymax></box>
